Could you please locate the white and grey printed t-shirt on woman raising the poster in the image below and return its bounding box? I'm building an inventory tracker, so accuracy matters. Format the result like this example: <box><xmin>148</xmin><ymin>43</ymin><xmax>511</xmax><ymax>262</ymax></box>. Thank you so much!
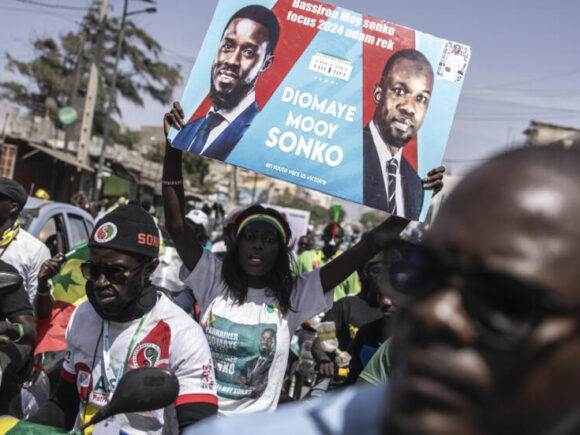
<box><xmin>184</xmin><ymin>250</ymin><xmax>333</xmax><ymax>415</ymax></box>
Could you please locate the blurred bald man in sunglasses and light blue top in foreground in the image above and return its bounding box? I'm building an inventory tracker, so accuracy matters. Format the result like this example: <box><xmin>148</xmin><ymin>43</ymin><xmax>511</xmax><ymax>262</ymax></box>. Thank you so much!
<box><xmin>188</xmin><ymin>147</ymin><xmax>580</xmax><ymax>435</ymax></box>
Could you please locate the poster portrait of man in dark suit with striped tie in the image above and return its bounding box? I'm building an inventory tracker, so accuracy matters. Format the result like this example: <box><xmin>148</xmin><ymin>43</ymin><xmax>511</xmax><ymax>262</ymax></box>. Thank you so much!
<box><xmin>363</xmin><ymin>49</ymin><xmax>433</xmax><ymax>220</ymax></box>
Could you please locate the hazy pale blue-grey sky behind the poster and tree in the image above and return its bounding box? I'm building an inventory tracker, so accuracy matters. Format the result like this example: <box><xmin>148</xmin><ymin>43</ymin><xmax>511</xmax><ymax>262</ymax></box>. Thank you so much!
<box><xmin>0</xmin><ymin>0</ymin><xmax>580</xmax><ymax>181</ymax></box>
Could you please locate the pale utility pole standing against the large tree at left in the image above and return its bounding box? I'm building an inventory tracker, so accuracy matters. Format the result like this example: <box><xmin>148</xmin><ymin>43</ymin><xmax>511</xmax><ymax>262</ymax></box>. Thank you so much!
<box><xmin>77</xmin><ymin>0</ymin><xmax>109</xmax><ymax>164</ymax></box>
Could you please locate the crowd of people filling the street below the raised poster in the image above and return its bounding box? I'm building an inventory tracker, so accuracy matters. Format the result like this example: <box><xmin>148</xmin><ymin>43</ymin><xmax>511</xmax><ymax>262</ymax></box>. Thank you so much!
<box><xmin>0</xmin><ymin>104</ymin><xmax>580</xmax><ymax>435</ymax></box>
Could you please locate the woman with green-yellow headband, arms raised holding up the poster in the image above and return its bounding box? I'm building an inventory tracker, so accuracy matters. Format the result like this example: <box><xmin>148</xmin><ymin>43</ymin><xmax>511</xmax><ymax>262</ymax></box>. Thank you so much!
<box><xmin>162</xmin><ymin>103</ymin><xmax>408</xmax><ymax>414</ymax></box>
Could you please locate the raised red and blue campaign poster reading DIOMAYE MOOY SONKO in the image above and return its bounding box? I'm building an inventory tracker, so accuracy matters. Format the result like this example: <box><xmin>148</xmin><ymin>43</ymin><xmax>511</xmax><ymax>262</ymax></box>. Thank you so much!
<box><xmin>169</xmin><ymin>0</ymin><xmax>471</xmax><ymax>220</ymax></box>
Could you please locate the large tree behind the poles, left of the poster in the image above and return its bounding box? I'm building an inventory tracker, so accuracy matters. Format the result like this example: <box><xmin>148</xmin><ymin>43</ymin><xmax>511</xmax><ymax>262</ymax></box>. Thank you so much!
<box><xmin>0</xmin><ymin>7</ymin><xmax>181</xmax><ymax>145</ymax></box>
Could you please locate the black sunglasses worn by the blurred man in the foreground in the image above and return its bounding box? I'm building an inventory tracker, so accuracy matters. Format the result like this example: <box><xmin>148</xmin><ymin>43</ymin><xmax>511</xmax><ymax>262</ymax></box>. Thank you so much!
<box><xmin>388</xmin><ymin>240</ymin><xmax>580</xmax><ymax>347</ymax></box>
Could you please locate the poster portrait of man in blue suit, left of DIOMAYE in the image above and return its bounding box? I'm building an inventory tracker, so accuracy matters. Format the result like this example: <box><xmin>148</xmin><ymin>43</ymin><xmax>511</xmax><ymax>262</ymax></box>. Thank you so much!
<box><xmin>172</xmin><ymin>5</ymin><xmax>280</xmax><ymax>161</ymax></box>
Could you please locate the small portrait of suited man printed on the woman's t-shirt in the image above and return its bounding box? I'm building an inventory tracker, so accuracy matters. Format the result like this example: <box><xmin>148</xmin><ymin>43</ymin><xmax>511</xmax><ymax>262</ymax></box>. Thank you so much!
<box><xmin>236</xmin><ymin>328</ymin><xmax>276</xmax><ymax>396</ymax></box>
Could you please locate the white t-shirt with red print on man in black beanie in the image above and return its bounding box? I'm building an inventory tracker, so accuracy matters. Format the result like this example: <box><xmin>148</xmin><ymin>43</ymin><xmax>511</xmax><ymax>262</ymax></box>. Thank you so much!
<box><xmin>63</xmin><ymin>293</ymin><xmax>217</xmax><ymax>434</ymax></box>
